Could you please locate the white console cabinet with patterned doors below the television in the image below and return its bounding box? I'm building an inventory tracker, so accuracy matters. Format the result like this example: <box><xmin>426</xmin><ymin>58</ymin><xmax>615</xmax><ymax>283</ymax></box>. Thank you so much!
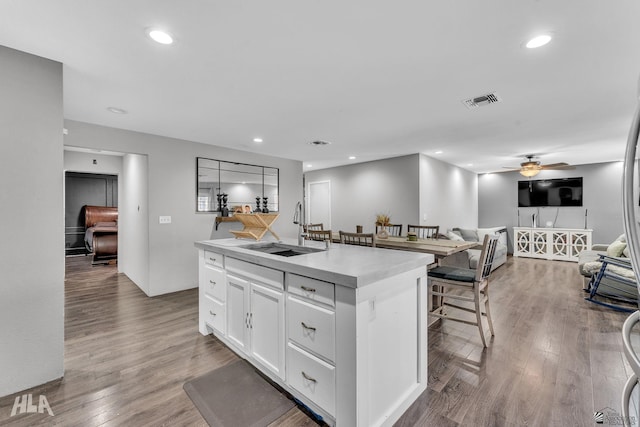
<box><xmin>513</xmin><ymin>227</ymin><xmax>593</xmax><ymax>262</ymax></box>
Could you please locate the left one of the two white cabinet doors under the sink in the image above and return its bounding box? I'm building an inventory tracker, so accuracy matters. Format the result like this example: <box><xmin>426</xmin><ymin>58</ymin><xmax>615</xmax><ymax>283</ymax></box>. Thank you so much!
<box><xmin>227</xmin><ymin>274</ymin><xmax>249</xmax><ymax>353</ymax></box>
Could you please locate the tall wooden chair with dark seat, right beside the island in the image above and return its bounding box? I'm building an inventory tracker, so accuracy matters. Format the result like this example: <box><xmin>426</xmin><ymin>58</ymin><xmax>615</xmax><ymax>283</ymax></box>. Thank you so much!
<box><xmin>428</xmin><ymin>235</ymin><xmax>498</xmax><ymax>347</ymax></box>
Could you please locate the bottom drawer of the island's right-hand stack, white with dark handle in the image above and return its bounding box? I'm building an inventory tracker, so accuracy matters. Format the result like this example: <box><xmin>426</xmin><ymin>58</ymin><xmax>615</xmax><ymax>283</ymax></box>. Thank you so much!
<box><xmin>287</xmin><ymin>344</ymin><xmax>336</xmax><ymax>416</ymax></box>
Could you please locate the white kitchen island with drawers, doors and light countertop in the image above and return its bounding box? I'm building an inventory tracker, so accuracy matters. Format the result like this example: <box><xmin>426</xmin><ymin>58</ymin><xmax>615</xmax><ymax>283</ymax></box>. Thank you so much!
<box><xmin>195</xmin><ymin>239</ymin><xmax>433</xmax><ymax>426</ymax></box>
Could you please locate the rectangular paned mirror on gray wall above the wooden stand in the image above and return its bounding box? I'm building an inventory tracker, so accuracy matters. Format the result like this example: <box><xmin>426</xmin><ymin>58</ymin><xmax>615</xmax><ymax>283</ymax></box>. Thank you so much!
<box><xmin>196</xmin><ymin>157</ymin><xmax>280</xmax><ymax>215</ymax></box>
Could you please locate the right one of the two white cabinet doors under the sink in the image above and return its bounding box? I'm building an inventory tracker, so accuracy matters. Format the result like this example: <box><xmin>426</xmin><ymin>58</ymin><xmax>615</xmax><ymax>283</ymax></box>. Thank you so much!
<box><xmin>249</xmin><ymin>282</ymin><xmax>285</xmax><ymax>379</ymax></box>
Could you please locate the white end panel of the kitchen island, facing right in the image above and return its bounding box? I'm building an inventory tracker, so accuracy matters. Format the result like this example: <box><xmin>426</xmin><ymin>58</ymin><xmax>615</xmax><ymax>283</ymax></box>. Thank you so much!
<box><xmin>356</xmin><ymin>267</ymin><xmax>427</xmax><ymax>426</ymax></box>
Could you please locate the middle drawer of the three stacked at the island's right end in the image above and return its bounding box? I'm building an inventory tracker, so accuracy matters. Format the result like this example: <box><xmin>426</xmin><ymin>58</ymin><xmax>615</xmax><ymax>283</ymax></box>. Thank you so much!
<box><xmin>287</xmin><ymin>297</ymin><xmax>335</xmax><ymax>361</ymax></box>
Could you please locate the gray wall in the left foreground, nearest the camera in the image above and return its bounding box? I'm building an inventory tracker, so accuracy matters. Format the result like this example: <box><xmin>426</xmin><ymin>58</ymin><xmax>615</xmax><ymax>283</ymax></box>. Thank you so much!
<box><xmin>0</xmin><ymin>46</ymin><xmax>64</xmax><ymax>396</ymax></box>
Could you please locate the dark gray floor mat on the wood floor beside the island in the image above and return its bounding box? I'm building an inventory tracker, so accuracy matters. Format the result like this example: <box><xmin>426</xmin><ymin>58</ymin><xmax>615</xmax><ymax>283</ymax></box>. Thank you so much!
<box><xmin>184</xmin><ymin>360</ymin><xmax>295</xmax><ymax>427</ymax></box>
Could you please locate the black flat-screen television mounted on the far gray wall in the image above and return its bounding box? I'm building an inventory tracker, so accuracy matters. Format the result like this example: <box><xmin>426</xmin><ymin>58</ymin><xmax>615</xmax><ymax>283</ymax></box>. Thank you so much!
<box><xmin>518</xmin><ymin>177</ymin><xmax>582</xmax><ymax>208</ymax></box>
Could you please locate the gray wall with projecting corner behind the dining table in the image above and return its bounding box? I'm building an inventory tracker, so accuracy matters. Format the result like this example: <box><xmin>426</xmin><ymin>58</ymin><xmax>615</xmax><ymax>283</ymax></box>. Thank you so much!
<box><xmin>305</xmin><ymin>154</ymin><xmax>478</xmax><ymax>233</ymax></box>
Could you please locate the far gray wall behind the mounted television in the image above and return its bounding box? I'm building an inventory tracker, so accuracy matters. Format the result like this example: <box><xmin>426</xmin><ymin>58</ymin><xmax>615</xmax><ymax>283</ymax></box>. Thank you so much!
<box><xmin>478</xmin><ymin>162</ymin><xmax>624</xmax><ymax>252</ymax></box>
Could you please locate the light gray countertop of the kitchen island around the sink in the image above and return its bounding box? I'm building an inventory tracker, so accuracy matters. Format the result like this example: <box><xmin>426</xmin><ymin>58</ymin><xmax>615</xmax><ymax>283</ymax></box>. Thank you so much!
<box><xmin>195</xmin><ymin>238</ymin><xmax>434</xmax><ymax>288</ymax></box>
